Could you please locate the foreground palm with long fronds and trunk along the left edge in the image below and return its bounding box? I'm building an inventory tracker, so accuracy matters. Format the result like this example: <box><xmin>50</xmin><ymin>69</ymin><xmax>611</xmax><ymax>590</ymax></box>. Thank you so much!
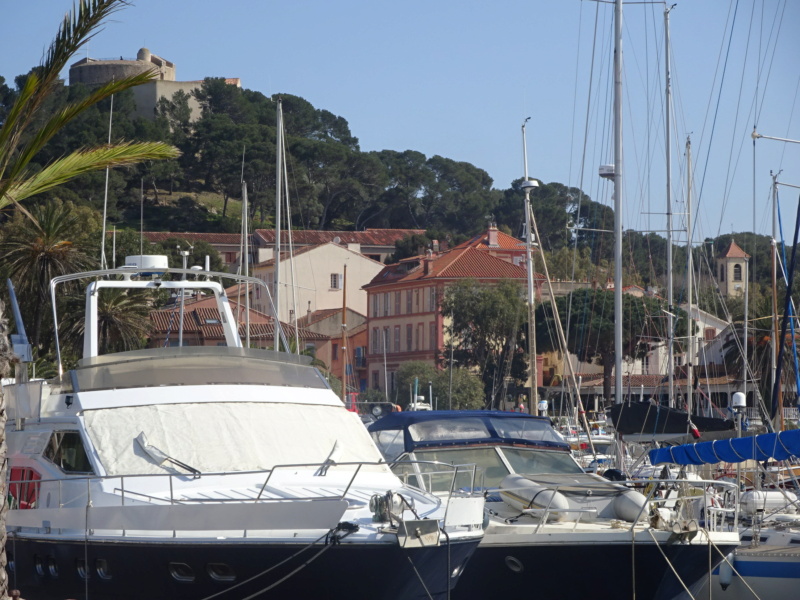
<box><xmin>0</xmin><ymin>0</ymin><xmax>179</xmax><ymax>600</ymax></box>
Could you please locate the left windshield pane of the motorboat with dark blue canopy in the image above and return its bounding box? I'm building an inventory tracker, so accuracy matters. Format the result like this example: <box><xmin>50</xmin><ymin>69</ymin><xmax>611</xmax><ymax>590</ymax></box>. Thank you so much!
<box><xmin>414</xmin><ymin>446</ymin><xmax>509</xmax><ymax>491</ymax></box>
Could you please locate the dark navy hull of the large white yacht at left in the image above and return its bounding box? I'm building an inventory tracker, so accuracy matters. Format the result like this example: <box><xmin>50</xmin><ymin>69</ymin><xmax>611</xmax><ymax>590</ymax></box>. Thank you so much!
<box><xmin>7</xmin><ymin>538</ymin><xmax>478</xmax><ymax>600</ymax></box>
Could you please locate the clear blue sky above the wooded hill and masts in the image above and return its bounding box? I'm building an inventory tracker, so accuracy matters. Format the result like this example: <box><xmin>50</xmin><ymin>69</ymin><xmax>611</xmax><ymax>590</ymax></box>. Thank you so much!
<box><xmin>0</xmin><ymin>0</ymin><xmax>800</xmax><ymax>241</ymax></box>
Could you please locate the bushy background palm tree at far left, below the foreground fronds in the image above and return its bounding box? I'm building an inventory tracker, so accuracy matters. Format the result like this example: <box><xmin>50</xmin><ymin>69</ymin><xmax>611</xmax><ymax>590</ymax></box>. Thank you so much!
<box><xmin>0</xmin><ymin>201</ymin><xmax>94</xmax><ymax>349</ymax></box>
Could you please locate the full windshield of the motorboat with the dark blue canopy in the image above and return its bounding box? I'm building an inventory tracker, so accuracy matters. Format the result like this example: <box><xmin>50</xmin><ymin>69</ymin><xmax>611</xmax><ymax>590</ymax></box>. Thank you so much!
<box><xmin>392</xmin><ymin>445</ymin><xmax>583</xmax><ymax>492</ymax></box>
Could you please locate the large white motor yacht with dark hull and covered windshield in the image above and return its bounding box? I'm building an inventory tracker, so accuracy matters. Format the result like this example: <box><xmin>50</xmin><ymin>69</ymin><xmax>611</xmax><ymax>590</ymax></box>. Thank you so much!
<box><xmin>4</xmin><ymin>257</ymin><xmax>483</xmax><ymax>600</ymax></box>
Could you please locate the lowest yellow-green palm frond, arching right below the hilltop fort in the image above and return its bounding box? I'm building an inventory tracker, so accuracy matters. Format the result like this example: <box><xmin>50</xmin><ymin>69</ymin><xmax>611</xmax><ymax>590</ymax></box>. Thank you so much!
<box><xmin>0</xmin><ymin>142</ymin><xmax>180</xmax><ymax>209</ymax></box>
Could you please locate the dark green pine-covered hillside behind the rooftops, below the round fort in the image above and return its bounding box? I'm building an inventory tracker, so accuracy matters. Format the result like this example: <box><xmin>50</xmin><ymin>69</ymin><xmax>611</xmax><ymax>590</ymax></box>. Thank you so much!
<box><xmin>0</xmin><ymin>71</ymin><xmax>784</xmax><ymax>328</ymax></box>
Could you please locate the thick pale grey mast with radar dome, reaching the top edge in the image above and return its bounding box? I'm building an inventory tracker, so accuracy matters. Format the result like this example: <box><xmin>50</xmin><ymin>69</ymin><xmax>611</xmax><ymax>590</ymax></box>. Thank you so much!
<box><xmin>614</xmin><ymin>0</ymin><xmax>622</xmax><ymax>402</ymax></box>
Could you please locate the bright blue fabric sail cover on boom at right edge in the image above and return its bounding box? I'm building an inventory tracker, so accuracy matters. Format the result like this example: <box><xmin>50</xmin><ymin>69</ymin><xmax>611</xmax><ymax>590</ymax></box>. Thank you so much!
<box><xmin>650</xmin><ymin>429</ymin><xmax>800</xmax><ymax>465</ymax></box>
